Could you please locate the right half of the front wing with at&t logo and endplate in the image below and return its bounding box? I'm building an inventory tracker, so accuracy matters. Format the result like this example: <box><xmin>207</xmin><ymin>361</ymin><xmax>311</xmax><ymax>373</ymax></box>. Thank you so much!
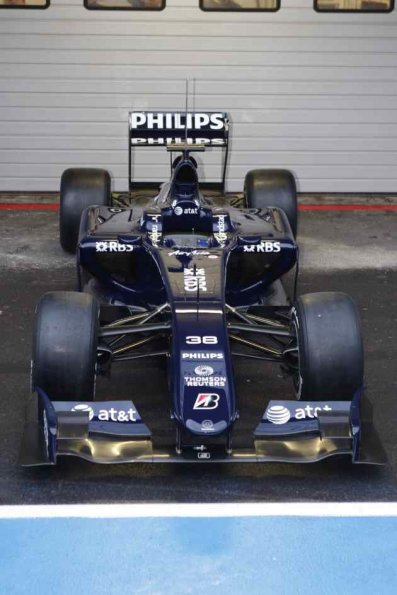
<box><xmin>254</xmin><ymin>390</ymin><xmax>387</xmax><ymax>465</ymax></box>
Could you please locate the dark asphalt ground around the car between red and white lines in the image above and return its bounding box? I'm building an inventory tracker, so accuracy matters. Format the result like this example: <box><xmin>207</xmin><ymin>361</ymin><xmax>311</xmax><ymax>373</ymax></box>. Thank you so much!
<box><xmin>0</xmin><ymin>211</ymin><xmax>397</xmax><ymax>504</ymax></box>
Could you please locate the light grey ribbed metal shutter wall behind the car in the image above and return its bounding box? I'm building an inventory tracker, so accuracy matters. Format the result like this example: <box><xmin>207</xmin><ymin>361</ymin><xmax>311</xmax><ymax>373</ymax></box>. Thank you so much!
<box><xmin>0</xmin><ymin>0</ymin><xmax>397</xmax><ymax>192</ymax></box>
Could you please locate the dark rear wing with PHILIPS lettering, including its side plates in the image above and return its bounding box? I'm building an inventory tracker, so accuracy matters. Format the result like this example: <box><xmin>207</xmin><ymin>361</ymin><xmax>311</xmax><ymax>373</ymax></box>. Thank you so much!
<box><xmin>128</xmin><ymin>111</ymin><xmax>229</xmax><ymax>192</ymax></box>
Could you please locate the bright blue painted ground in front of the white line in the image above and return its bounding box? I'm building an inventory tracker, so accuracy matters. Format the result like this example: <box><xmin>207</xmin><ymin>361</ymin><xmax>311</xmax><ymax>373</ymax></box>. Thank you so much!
<box><xmin>0</xmin><ymin>517</ymin><xmax>397</xmax><ymax>595</ymax></box>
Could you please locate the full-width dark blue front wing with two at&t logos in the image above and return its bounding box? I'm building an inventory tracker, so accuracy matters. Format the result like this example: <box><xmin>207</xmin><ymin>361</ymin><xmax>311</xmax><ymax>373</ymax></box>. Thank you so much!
<box><xmin>20</xmin><ymin>389</ymin><xmax>387</xmax><ymax>466</ymax></box>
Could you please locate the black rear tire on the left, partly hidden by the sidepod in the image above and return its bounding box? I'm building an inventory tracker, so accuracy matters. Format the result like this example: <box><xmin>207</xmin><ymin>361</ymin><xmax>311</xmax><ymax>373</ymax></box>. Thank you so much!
<box><xmin>59</xmin><ymin>168</ymin><xmax>111</xmax><ymax>254</ymax></box>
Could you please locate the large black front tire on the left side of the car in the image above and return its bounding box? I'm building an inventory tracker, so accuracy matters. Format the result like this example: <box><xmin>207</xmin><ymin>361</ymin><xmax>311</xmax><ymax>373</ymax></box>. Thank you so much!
<box><xmin>32</xmin><ymin>291</ymin><xmax>99</xmax><ymax>401</ymax></box>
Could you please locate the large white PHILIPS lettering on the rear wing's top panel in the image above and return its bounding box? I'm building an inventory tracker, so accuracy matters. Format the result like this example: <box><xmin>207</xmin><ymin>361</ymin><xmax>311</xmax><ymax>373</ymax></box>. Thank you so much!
<box><xmin>130</xmin><ymin>112</ymin><xmax>225</xmax><ymax>130</ymax></box>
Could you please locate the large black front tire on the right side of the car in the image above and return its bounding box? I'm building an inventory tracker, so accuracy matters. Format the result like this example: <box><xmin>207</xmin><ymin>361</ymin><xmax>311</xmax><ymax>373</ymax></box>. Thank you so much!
<box><xmin>292</xmin><ymin>292</ymin><xmax>364</xmax><ymax>401</ymax></box>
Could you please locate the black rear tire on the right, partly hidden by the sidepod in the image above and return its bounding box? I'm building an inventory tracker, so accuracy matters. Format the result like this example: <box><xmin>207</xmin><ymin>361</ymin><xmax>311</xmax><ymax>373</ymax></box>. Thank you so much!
<box><xmin>244</xmin><ymin>169</ymin><xmax>298</xmax><ymax>237</ymax></box>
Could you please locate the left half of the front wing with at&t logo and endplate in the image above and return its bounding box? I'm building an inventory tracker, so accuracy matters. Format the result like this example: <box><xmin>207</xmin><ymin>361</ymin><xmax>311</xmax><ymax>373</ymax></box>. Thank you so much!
<box><xmin>20</xmin><ymin>389</ymin><xmax>152</xmax><ymax>467</ymax></box>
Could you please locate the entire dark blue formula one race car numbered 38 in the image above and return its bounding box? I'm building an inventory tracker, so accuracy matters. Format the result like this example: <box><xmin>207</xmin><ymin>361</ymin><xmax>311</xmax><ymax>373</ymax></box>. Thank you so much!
<box><xmin>21</xmin><ymin>112</ymin><xmax>385</xmax><ymax>465</ymax></box>
